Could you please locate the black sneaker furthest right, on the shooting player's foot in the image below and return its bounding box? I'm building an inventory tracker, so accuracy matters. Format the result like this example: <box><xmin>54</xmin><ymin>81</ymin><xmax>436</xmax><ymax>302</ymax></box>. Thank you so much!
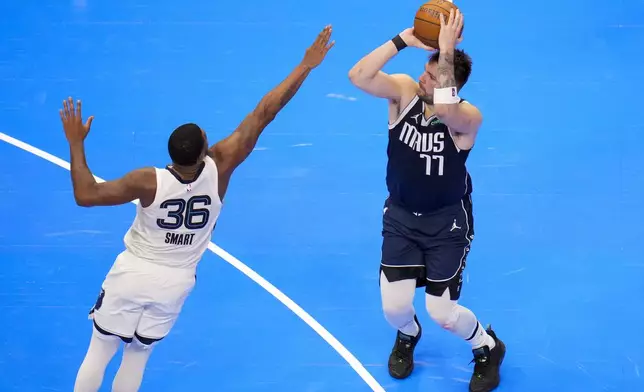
<box><xmin>470</xmin><ymin>326</ymin><xmax>505</xmax><ymax>392</ymax></box>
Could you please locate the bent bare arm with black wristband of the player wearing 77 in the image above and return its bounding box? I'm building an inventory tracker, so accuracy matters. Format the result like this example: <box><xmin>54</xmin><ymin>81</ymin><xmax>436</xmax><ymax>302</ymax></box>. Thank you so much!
<box><xmin>349</xmin><ymin>28</ymin><xmax>434</xmax><ymax>102</ymax></box>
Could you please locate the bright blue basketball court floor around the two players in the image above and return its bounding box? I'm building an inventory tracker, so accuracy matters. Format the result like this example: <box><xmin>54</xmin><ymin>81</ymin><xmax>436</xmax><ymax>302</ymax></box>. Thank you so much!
<box><xmin>0</xmin><ymin>0</ymin><xmax>644</xmax><ymax>392</ymax></box>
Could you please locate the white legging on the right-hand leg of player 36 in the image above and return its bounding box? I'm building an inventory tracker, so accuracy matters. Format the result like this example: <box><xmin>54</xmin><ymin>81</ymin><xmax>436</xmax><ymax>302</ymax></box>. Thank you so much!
<box><xmin>112</xmin><ymin>337</ymin><xmax>153</xmax><ymax>392</ymax></box>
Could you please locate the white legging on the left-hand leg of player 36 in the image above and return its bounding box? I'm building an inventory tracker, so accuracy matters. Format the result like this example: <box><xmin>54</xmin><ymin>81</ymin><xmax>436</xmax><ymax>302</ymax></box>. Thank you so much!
<box><xmin>74</xmin><ymin>328</ymin><xmax>121</xmax><ymax>392</ymax></box>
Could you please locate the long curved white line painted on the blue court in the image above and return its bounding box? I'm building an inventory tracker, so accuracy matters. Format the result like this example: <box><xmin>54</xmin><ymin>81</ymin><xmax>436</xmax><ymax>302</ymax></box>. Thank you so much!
<box><xmin>0</xmin><ymin>132</ymin><xmax>385</xmax><ymax>392</ymax></box>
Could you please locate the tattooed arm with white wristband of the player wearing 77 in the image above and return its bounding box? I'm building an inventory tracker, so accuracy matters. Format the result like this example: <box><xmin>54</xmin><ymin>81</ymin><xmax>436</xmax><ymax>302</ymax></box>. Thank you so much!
<box><xmin>434</xmin><ymin>9</ymin><xmax>483</xmax><ymax>134</ymax></box>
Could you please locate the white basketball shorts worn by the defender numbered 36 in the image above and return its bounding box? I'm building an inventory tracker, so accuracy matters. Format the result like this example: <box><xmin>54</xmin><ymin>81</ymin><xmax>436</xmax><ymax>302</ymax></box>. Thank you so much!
<box><xmin>90</xmin><ymin>251</ymin><xmax>196</xmax><ymax>339</ymax></box>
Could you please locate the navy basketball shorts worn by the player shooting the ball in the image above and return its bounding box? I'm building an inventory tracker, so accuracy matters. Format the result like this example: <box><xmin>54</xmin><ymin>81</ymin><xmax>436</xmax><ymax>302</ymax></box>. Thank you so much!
<box><xmin>380</xmin><ymin>195</ymin><xmax>474</xmax><ymax>300</ymax></box>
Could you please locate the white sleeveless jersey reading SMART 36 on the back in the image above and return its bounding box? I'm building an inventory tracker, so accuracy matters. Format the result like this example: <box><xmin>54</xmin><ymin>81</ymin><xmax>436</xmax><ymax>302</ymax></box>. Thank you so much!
<box><xmin>124</xmin><ymin>156</ymin><xmax>221</xmax><ymax>269</ymax></box>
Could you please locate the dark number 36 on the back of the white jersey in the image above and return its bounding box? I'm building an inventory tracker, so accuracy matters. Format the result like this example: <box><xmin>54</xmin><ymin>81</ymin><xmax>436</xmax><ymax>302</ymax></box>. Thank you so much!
<box><xmin>157</xmin><ymin>195</ymin><xmax>211</xmax><ymax>230</ymax></box>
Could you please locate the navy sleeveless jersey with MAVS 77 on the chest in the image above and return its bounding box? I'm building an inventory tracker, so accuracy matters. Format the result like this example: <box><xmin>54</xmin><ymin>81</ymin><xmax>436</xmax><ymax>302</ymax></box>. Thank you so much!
<box><xmin>387</xmin><ymin>96</ymin><xmax>472</xmax><ymax>213</ymax></box>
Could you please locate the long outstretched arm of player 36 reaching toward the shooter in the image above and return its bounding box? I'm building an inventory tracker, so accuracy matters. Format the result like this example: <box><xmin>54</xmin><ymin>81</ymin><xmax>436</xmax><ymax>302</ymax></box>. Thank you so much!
<box><xmin>210</xmin><ymin>26</ymin><xmax>335</xmax><ymax>176</ymax></box>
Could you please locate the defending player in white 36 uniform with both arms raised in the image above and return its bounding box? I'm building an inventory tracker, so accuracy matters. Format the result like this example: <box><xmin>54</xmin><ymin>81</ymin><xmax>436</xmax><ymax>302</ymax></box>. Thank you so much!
<box><xmin>60</xmin><ymin>26</ymin><xmax>334</xmax><ymax>392</ymax></box>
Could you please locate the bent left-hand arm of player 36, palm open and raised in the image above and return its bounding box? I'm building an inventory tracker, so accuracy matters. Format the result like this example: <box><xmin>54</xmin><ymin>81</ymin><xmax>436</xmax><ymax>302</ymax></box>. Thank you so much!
<box><xmin>60</xmin><ymin>97</ymin><xmax>156</xmax><ymax>207</ymax></box>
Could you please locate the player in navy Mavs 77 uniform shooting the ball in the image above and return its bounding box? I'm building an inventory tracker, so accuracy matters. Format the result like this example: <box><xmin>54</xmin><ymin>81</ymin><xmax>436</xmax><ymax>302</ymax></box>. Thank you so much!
<box><xmin>349</xmin><ymin>11</ymin><xmax>505</xmax><ymax>392</ymax></box>
